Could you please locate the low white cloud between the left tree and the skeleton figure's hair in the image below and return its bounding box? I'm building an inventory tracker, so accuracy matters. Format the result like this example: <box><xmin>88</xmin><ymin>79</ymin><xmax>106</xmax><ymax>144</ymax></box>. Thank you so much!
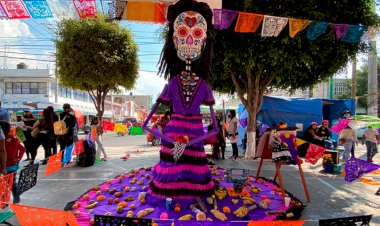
<box><xmin>127</xmin><ymin>71</ymin><xmax>167</xmax><ymax>97</ymax></box>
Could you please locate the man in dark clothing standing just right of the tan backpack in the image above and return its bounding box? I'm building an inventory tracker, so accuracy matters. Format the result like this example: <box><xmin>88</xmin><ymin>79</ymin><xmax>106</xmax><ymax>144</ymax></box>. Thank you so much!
<box><xmin>58</xmin><ymin>103</ymin><xmax>76</xmax><ymax>151</ymax></box>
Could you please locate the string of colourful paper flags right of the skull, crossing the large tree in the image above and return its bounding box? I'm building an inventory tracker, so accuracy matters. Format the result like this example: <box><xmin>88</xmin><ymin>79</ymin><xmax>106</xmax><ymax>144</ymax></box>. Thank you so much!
<box><xmin>214</xmin><ymin>9</ymin><xmax>379</xmax><ymax>43</ymax></box>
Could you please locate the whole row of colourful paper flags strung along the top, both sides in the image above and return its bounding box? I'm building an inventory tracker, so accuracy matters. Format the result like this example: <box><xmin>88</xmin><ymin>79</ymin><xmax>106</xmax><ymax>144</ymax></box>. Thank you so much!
<box><xmin>0</xmin><ymin>0</ymin><xmax>379</xmax><ymax>43</ymax></box>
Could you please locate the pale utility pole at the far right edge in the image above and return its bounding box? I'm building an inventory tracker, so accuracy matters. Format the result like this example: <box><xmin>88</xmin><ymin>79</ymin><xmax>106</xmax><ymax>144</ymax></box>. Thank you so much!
<box><xmin>367</xmin><ymin>1</ymin><xmax>378</xmax><ymax>116</ymax></box>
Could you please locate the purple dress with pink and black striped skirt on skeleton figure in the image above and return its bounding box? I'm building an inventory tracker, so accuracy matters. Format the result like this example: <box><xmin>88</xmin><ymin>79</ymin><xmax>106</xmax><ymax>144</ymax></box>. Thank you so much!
<box><xmin>149</xmin><ymin>76</ymin><xmax>215</xmax><ymax>198</ymax></box>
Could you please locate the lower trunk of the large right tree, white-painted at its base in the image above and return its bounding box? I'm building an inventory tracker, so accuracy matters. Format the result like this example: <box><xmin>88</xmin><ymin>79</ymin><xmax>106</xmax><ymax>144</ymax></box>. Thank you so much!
<box><xmin>245</xmin><ymin>111</ymin><xmax>256</xmax><ymax>159</ymax></box>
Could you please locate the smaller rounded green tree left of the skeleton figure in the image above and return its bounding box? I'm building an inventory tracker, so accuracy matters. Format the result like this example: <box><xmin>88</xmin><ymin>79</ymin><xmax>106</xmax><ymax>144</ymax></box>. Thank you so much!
<box><xmin>56</xmin><ymin>16</ymin><xmax>138</xmax><ymax>118</ymax></box>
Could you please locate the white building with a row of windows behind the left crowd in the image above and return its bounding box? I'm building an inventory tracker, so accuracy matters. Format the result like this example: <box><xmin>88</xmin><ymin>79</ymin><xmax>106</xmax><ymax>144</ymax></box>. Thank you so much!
<box><xmin>0</xmin><ymin>66</ymin><xmax>114</xmax><ymax>118</ymax></box>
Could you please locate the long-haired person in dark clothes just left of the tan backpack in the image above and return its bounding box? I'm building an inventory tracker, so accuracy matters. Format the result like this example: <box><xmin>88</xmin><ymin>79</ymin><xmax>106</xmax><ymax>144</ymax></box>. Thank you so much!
<box><xmin>29</xmin><ymin>109</ymin><xmax>53</xmax><ymax>165</ymax></box>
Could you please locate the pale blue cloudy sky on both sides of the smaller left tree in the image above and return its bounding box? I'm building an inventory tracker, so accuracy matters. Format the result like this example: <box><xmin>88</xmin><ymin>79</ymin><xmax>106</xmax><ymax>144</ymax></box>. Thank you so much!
<box><xmin>0</xmin><ymin>0</ymin><xmax>166</xmax><ymax>96</ymax></box>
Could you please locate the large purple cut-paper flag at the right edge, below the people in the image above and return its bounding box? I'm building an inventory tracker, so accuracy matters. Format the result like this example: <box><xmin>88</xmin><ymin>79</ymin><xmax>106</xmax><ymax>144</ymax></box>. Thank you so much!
<box><xmin>344</xmin><ymin>157</ymin><xmax>380</xmax><ymax>182</ymax></box>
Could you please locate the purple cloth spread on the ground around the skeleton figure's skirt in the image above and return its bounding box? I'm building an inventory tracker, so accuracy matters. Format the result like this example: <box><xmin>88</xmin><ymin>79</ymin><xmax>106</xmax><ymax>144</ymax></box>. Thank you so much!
<box><xmin>76</xmin><ymin>170</ymin><xmax>300</xmax><ymax>225</ymax></box>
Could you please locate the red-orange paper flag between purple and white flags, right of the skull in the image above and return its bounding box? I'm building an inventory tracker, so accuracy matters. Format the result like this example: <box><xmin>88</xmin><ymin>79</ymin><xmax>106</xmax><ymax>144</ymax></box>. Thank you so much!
<box><xmin>235</xmin><ymin>12</ymin><xmax>264</xmax><ymax>33</ymax></box>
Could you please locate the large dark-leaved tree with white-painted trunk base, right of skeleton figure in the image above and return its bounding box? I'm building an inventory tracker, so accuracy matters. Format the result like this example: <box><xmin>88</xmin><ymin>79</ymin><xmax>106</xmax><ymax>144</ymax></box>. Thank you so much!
<box><xmin>209</xmin><ymin>0</ymin><xmax>378</xmax><ymax>158</ymax></box>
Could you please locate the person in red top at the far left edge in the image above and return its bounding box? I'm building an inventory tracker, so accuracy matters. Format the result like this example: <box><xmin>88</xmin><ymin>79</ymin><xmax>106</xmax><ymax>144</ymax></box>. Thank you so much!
<box><xmin>0</xmin><ymin>121</ymin><xmax>25</xmax><ymax>204</ymax></box>
